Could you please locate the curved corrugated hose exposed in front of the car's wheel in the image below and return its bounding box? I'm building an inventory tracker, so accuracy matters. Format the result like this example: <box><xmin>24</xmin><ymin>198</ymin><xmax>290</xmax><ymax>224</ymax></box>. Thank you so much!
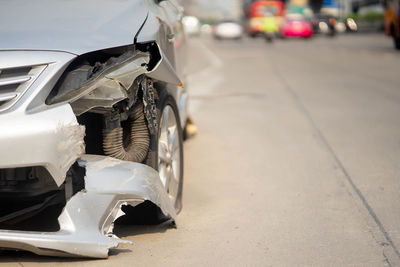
<box><xmin>103</xmin><ymin>104</ymin><xmax>150</xmax><ymax>162</ymax></box>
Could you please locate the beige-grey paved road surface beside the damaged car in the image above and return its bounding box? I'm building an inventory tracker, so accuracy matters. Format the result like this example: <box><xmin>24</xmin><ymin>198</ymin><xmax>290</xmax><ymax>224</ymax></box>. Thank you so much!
<box><xmin>0</xmin><ymin>34</ymin><xmax>400</xmax><ymax>266</ymax></box>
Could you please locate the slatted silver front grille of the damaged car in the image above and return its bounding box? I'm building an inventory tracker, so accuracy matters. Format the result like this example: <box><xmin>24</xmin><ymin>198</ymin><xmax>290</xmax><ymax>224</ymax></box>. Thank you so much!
<box><xmin>0</xmin><ymin>65</ymin><xmax>46</xmax><ymax>112</ymax></box>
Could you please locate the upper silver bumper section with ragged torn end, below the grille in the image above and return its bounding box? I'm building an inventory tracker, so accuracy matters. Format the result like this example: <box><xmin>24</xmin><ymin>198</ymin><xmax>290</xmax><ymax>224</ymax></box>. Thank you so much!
<box><xmin>0</xmin><ymin>104</ymin><xmax>85</xmax><ymax>186</ymax></box>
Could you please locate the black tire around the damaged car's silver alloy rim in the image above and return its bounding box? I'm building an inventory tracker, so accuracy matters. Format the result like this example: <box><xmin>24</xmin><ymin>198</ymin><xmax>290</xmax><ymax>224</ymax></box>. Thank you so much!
<box><xmin>146</xmin><ymin>90</ymin><xmax>183</xmax><ymax>213</ymax></box>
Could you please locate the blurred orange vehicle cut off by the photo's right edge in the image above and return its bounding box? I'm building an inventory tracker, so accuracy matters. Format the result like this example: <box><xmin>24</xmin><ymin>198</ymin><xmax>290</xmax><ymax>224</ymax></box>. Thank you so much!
<box><xmin>384</xmin><ymin>0</ymin><xmax>400</xmax><ymax>49</ymax></box>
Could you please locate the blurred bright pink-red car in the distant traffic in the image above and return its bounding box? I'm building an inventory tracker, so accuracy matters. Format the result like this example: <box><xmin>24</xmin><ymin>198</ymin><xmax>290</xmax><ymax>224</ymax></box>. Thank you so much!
<box><xmin>281</xmin><ymin>14</ymin><xmax>313</xmax><ymax>38</ymax></box>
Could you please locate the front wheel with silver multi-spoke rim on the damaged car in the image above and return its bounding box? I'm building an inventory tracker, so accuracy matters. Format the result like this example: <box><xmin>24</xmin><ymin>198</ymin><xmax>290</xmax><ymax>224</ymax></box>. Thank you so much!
<box><xmin>154</xmin><ymin>94</ymin><xmax>183</xmax><ymax>212</ymax></box>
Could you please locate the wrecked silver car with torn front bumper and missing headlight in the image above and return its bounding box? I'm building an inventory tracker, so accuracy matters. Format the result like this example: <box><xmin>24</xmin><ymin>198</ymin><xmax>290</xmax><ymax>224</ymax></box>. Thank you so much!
<box><xmin>0</xmin><ymin>0</ymin><xmax>187</xmax><ymax>258</ymax></box>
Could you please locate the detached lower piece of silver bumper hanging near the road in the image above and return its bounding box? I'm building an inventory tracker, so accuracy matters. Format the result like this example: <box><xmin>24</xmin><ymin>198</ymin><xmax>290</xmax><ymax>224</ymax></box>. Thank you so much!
<box><xmin>0</xmin><ymin>155</ymin><xmax>176</xmax><ymax>258</ymax></box>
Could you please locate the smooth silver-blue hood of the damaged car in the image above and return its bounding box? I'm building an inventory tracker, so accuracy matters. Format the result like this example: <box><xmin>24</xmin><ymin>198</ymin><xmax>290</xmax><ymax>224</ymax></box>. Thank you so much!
<box><xmin>0</xmin><ymin>0</ymin><xmax>148</xmax><ymax>55</ymax></box>
